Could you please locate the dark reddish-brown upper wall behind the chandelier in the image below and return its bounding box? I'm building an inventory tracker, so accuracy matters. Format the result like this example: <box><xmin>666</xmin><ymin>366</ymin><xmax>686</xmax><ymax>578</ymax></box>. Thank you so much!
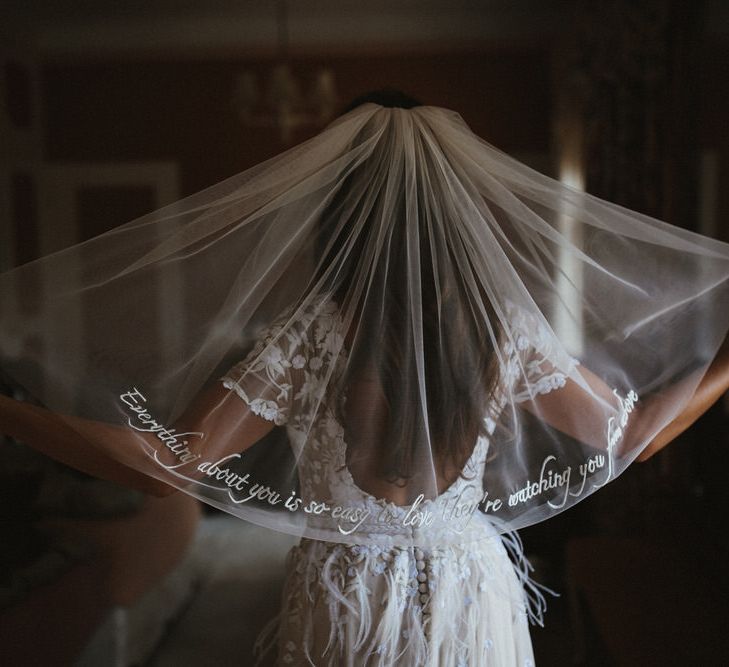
<box><xmin>43</xmin><ymin>47</ymin><xmax>550</xmax><ymax>202</ymax></box>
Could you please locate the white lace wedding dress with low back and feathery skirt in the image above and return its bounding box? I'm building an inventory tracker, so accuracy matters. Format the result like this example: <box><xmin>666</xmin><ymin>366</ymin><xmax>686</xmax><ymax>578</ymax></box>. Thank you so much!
<box><xmin>220</xmin><ymin>300</ymin><xmax>565</xmax><ymax>667</ymax></box>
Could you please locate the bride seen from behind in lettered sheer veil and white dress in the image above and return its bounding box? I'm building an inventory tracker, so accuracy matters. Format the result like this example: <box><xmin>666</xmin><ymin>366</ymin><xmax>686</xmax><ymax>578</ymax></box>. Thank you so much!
<box><xmin>0</xmin><ymin>91</ymin><xmax>729</xmax><ymax>666</ymax></box>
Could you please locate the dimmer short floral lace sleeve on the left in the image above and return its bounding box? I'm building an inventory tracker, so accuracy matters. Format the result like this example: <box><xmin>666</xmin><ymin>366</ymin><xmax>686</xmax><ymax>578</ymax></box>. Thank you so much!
<box><xmin>219</xmin><ymin>318</ymin><xmax>303</xmax><ymax>426</ymax></box>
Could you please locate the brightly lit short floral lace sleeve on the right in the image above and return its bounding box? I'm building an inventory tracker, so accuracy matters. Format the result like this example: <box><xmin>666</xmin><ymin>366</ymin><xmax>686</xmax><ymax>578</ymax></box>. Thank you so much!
<box><xmin>505</xmin><ymin>304</ymin><xmax>579</xmax><ymax>403</ymax></box>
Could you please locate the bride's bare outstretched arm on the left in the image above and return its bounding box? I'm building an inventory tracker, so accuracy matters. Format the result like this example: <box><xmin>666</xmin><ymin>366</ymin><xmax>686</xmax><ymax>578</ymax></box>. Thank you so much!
<box><xmin>0</xmin><ymin>383</ymin><xmax>273</xmax><ymax>496</ymax></box>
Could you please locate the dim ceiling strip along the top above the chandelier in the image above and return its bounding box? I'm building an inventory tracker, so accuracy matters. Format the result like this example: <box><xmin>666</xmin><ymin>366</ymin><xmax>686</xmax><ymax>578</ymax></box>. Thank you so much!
<box><xmin>5</xmin><ymin>0</ymin><xmax>729</xmax><ymax>57</ymax></box>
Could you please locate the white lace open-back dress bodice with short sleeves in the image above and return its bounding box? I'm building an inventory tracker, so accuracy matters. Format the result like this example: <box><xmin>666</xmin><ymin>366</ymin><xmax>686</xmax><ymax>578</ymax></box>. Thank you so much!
<box><xmin>222</xmin><ymin>299</ymin><xmax>576</xmax><ymax>544</ymax></box>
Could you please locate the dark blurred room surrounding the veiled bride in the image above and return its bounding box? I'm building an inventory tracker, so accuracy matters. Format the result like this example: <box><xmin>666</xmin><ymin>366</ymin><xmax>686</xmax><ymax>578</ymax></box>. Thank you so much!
<box><xmin>0</xmin><ymin>0</ymin><xmax>729</xmax><ymax>667</ymax></box>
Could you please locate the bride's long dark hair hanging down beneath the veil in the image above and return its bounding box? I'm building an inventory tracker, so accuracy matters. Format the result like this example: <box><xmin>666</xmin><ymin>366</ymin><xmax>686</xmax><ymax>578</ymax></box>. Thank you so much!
<box><xmin>310</xmin><ymin>89</ymin><xmax>500</xmax><ymax>486</ymax></box>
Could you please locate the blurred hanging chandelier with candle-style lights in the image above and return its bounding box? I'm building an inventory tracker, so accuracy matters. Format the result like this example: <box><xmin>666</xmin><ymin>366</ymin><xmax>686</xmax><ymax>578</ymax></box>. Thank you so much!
<box><xmin>233</xmin><ymin>0</ymin><xmax>337</xmax><ymax>144</ymax></box>
